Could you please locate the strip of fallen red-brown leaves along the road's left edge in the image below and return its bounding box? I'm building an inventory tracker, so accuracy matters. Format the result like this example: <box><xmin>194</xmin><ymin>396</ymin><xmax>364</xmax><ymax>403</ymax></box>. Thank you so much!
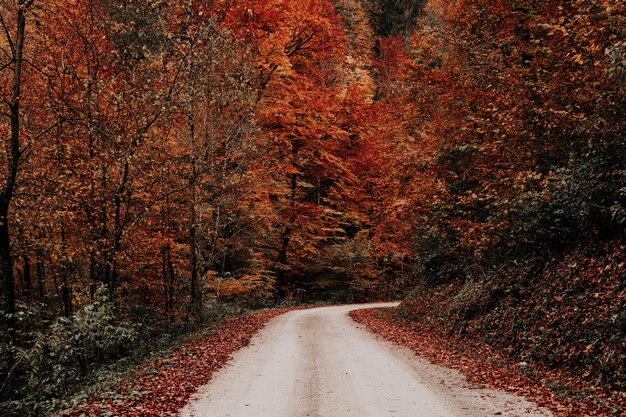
<box><xmin>61</xmin><ymin>309</ymin><xmax>289</xmax><ymax>417</ymax></box>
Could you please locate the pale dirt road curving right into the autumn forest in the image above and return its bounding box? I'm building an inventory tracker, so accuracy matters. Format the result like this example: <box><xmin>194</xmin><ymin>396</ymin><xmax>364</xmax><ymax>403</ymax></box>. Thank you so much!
<box><xmin>181</xmin><ymin>304</ymin><xmax>550</xmax><ymax>417</ymax></box>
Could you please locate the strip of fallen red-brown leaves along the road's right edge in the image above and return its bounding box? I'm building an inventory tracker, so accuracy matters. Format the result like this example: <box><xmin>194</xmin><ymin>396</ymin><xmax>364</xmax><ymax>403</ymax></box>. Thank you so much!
<box><xmin>350</xmin><ymin>309</ymin><xmax>626</xmax><ymax>417</ymax></box>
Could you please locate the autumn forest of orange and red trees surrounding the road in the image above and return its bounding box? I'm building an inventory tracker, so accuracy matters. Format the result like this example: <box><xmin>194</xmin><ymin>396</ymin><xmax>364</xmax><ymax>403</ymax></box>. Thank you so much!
<box><xmin>0</xmin><ymin>0</ymin><xmax>626</xmax><ymax>415</ymax></box>
